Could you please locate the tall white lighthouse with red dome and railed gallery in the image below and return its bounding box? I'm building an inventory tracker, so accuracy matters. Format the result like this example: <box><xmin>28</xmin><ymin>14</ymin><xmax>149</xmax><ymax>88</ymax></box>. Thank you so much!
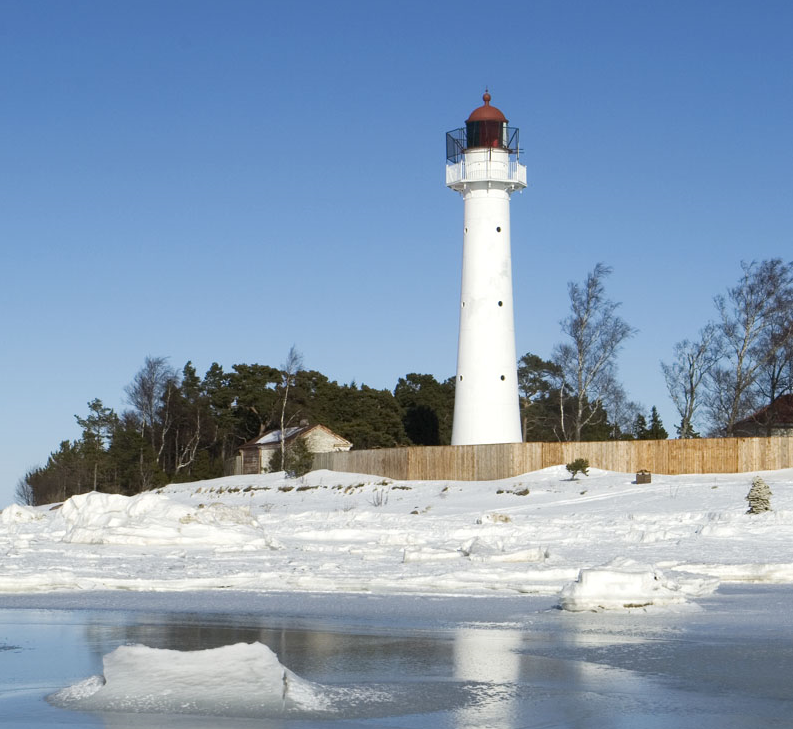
<box><xmin>446</xmin><ymin>91</ymin><xmax>526</xmax><ymax>445</ymax></box>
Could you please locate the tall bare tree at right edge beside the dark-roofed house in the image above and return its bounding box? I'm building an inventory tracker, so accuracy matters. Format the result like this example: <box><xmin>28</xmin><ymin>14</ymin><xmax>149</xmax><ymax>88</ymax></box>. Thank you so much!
<box><xmin>708</xmin><ymin>258</ymin><xmax>793</xmax><ymax>436</ymax></box>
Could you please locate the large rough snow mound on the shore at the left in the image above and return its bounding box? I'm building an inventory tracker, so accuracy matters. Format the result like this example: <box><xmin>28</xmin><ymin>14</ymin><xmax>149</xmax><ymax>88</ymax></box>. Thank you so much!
<box><xmin>60</xmin><ymin>491</ymin><xmax>277</xmax><ymax>548</ymax></box>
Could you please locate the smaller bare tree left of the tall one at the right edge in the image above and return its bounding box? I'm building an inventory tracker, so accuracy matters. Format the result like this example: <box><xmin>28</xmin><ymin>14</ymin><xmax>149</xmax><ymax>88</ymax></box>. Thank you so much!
<box><xmin>661</xmin><ymin>322</ymin><xmax>721</xmax><ymax>438</ymax></box>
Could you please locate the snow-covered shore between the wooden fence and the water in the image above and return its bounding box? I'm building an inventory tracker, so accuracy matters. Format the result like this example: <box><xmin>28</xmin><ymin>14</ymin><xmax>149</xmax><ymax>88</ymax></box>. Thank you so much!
<box><xmin>0</xmin><ymin>466</ymin><xmax>793</xmax><ymax>610</ymax></box>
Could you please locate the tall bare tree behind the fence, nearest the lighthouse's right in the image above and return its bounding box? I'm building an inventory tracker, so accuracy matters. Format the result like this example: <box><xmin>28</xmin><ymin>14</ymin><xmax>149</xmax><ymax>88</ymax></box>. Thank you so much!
<box><xmin>553</xmin><ymin>263</ymin><xmax>636</xmax><ymax>440</ymax></box>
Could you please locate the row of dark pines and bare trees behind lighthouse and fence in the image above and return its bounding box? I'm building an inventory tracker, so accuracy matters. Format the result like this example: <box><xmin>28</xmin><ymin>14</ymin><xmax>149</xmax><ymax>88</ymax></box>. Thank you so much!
<box><xmin>17</xmin><ymin>259</ymin><xmax>793</xmax><ymax>504</ymax></box>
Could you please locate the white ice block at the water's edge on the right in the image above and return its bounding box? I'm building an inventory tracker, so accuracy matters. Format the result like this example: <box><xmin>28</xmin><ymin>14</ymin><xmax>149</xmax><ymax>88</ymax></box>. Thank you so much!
<box><xmin>559</xmin><ymin>558</ymin><xmax>719</xmax><ymax>611</ymax></box>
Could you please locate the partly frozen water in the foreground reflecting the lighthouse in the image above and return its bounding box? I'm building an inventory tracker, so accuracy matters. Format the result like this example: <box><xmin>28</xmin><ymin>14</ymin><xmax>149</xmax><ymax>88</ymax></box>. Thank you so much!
<box><xmin>0</xmin><ymin>586</ymin><xmax>793</xmax><ymax>729</ymax></box>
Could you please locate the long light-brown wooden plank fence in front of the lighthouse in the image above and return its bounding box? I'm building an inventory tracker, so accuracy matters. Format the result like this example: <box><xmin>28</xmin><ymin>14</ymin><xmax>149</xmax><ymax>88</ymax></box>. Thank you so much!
<box><xmin>314</xmin><ymin>437</ymin><xmax>793</xmax><ymax>481</ymax></box>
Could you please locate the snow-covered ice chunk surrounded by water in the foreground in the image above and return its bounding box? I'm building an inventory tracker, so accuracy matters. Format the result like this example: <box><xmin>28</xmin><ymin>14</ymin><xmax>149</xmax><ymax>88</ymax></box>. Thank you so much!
<box><xmin>48</xmin><ymin>643</ymin><xmax>329</xmax><ymax>717</ymax></box>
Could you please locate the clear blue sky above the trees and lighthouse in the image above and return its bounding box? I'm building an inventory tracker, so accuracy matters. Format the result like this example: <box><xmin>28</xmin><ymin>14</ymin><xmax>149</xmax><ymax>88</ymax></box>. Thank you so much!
<box><xmin>0</xmin><ymin>0</ymin><xmax>793</xmax><ymax>504</ymax></box>
